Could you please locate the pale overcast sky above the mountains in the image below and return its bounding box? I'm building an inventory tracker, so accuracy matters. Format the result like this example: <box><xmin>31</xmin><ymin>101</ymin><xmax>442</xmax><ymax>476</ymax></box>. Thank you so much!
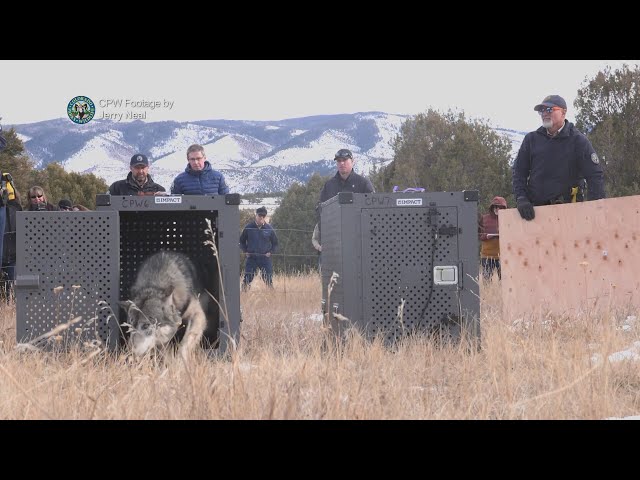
<box><xmin>0</xmin><ymin>60</ymin><xmax>640</xmax><ymax>131</ymax></box>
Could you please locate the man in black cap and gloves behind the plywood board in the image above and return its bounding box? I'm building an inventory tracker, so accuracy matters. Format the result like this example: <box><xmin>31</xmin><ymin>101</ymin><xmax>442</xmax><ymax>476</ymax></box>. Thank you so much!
<box><xmin>512</xmin><ymin>95</ymin><xmax>605</xmax><ymax>220</ymax></box>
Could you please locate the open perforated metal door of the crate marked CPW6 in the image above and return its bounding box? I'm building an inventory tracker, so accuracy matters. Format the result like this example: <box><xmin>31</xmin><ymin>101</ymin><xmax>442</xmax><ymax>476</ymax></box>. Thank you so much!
<box><xmin>16</xmin><ymin>212</ymin><xmax>118</xmax><ymax>348</ymax></box>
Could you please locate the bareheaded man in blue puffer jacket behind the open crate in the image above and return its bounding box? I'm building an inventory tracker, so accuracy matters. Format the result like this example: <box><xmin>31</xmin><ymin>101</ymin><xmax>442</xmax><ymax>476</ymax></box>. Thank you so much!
<box><xmin>171</xmin><ymin>144</ymin><xmax>229</xmax><ymax>195</ymax></box>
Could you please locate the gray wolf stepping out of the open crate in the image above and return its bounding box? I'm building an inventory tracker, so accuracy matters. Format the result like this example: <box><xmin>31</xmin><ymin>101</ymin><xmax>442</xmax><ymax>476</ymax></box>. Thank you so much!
<box><xmin>120</xmin><ymin>251</ymin><xmax>209</xmax><ymax>357</ymax></box>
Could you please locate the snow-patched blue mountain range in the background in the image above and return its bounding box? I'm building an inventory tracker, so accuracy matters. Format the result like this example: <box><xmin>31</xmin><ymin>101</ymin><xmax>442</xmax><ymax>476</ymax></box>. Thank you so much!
<box><xmin>8</xmin><ymin>112</ymin><xmax>524</xmax><ymax>193</ymax></box>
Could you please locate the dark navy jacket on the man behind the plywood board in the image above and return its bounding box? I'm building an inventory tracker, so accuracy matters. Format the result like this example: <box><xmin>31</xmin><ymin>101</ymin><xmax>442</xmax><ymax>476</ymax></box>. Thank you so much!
<box><xmin>512</xmin><ymin>120</ymin><xmax>605</xmax><ymax>205</ymax></box>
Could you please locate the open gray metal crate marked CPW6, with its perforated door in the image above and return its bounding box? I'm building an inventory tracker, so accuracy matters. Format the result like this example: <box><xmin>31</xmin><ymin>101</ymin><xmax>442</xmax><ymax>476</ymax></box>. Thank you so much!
<box><xmin>15</xmin><ymin>194</ymin><xmax>240</xmax><ymax>351</ymax></box>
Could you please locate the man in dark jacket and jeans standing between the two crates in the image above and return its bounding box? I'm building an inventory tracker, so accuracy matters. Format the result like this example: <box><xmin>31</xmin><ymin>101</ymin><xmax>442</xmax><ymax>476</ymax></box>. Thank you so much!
<box><xmin>240</xmin><ymin>207</ymin><xmax>278</xmax><ymax>290</ymax></box>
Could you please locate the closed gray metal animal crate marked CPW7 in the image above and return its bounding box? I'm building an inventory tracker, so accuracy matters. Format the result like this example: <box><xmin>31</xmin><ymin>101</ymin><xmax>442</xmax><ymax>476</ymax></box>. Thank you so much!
<box><xmin>321</xmin><ymin>190</ymin><xmax>480</xmax><ymax>343</ymax></box>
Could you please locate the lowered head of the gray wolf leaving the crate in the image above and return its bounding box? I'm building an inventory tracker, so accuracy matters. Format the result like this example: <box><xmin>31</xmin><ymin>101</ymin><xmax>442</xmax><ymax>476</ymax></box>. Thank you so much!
<box><xmin>121</xmin><ymin>295</ymin><xmax>182</xmax><ymax>356</ymax></box>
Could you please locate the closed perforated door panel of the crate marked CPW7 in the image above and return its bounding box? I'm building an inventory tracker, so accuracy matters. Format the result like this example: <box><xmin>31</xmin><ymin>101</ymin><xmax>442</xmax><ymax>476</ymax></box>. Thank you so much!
<box><xmin>361</xmin><ymin>207</ymin><xmax>458</xmax><ymax>341</ymax></box>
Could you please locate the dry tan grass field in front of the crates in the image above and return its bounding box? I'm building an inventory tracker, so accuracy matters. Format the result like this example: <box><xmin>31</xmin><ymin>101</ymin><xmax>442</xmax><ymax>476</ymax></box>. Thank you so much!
<box><xmin>0</xmin><ymin>275</ymin><xmax>640</xmax><ymax>419</ymax></box>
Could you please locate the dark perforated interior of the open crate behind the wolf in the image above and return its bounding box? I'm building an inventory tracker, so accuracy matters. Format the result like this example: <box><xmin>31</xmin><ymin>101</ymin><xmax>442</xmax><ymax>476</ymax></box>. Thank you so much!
<box><xmin>119</xmin><ymin>210</ymin><xmax>220</xmax><ymax>344</ymax></box>
